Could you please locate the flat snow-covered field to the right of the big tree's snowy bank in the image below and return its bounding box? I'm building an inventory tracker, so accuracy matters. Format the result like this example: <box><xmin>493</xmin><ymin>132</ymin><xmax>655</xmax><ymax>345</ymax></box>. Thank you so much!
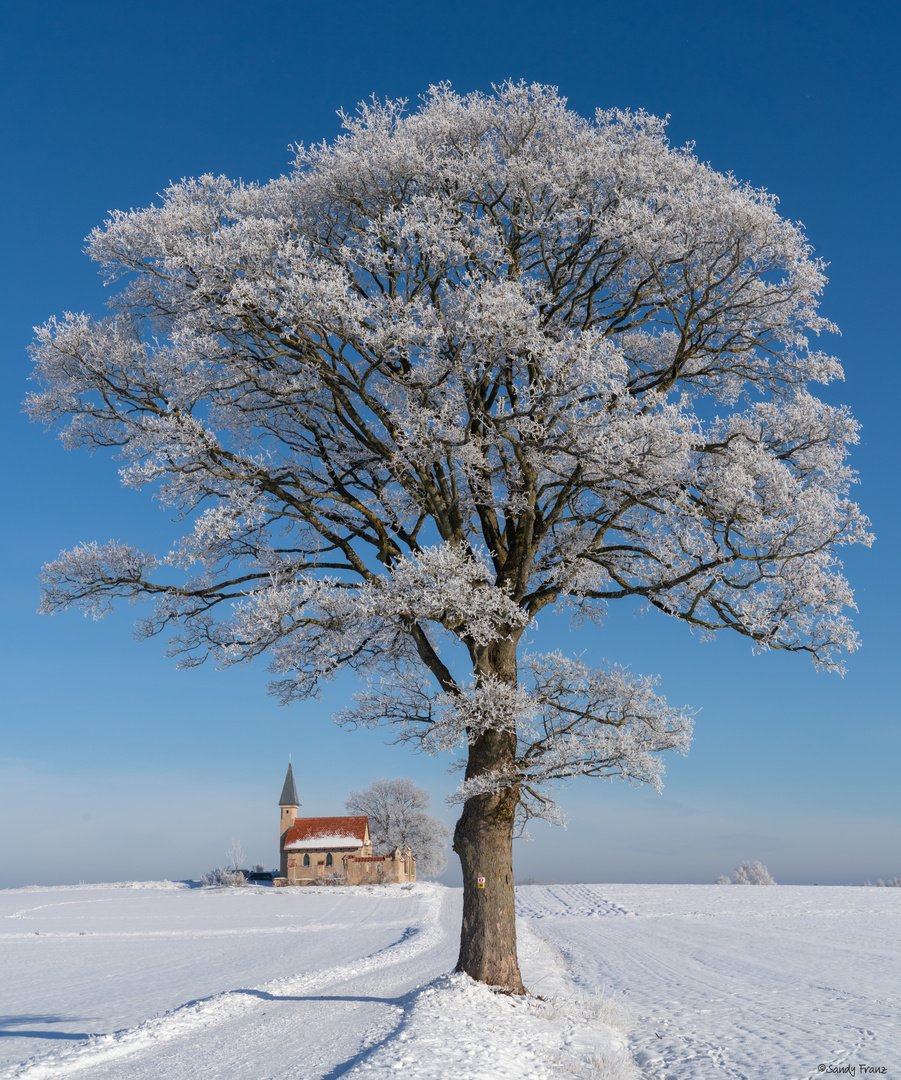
<box><xmin>516</xmin><ymin>885</ymin><xmax>901</xmax><ymax>1080</ymax></box>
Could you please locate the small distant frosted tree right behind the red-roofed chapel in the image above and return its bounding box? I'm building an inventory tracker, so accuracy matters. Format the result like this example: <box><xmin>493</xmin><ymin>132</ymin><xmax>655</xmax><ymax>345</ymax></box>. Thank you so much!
<box><xmin>345</xmin><ymin>778</ymin><xmax>451</xmax><ymax>878</ymax></box>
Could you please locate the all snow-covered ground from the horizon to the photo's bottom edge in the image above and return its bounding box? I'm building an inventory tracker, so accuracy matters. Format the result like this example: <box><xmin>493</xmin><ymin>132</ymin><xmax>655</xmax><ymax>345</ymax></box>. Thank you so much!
<box><xmin>0</xmin><ymin>882</ymin><xmax>901</xmax><ymax>1080</ymax></box>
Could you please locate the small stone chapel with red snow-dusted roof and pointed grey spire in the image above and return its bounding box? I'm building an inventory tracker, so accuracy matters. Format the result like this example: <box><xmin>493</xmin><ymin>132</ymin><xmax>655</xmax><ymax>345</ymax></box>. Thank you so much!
<box><xmin>273</xmin><ymin>761</ymin><xmax>416</xmax><ymax>886</ymax></box>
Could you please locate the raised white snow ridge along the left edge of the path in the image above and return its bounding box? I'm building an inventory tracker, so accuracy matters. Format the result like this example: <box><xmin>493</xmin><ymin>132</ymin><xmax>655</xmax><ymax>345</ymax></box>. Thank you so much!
<box><xmin>2</xmin><ymin>889</ymin><xmax>446</xmax><ymax>1080</ymax></box>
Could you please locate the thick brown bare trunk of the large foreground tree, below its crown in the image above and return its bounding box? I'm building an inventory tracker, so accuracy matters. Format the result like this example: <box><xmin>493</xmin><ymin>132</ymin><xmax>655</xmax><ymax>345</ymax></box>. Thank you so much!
<box><xmin>454</xmin><ymin>731</ymin><xmax>526</xmax><ymax>994</ymax></box>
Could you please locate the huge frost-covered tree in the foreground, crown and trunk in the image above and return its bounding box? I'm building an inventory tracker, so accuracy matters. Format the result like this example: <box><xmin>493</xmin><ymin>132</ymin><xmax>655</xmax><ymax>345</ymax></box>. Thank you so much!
<box><xmin>29</xmin><ymin>83</ymin><xmax>868</xmax><ymax>990</ymax></box>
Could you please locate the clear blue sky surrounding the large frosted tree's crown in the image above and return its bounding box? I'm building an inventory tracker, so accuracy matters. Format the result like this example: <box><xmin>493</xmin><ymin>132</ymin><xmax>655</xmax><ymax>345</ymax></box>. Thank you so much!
<box><xmin>0</xmin><ymin>0</ymin><xmax>901</xmax><ymax>887</ymax></box>
